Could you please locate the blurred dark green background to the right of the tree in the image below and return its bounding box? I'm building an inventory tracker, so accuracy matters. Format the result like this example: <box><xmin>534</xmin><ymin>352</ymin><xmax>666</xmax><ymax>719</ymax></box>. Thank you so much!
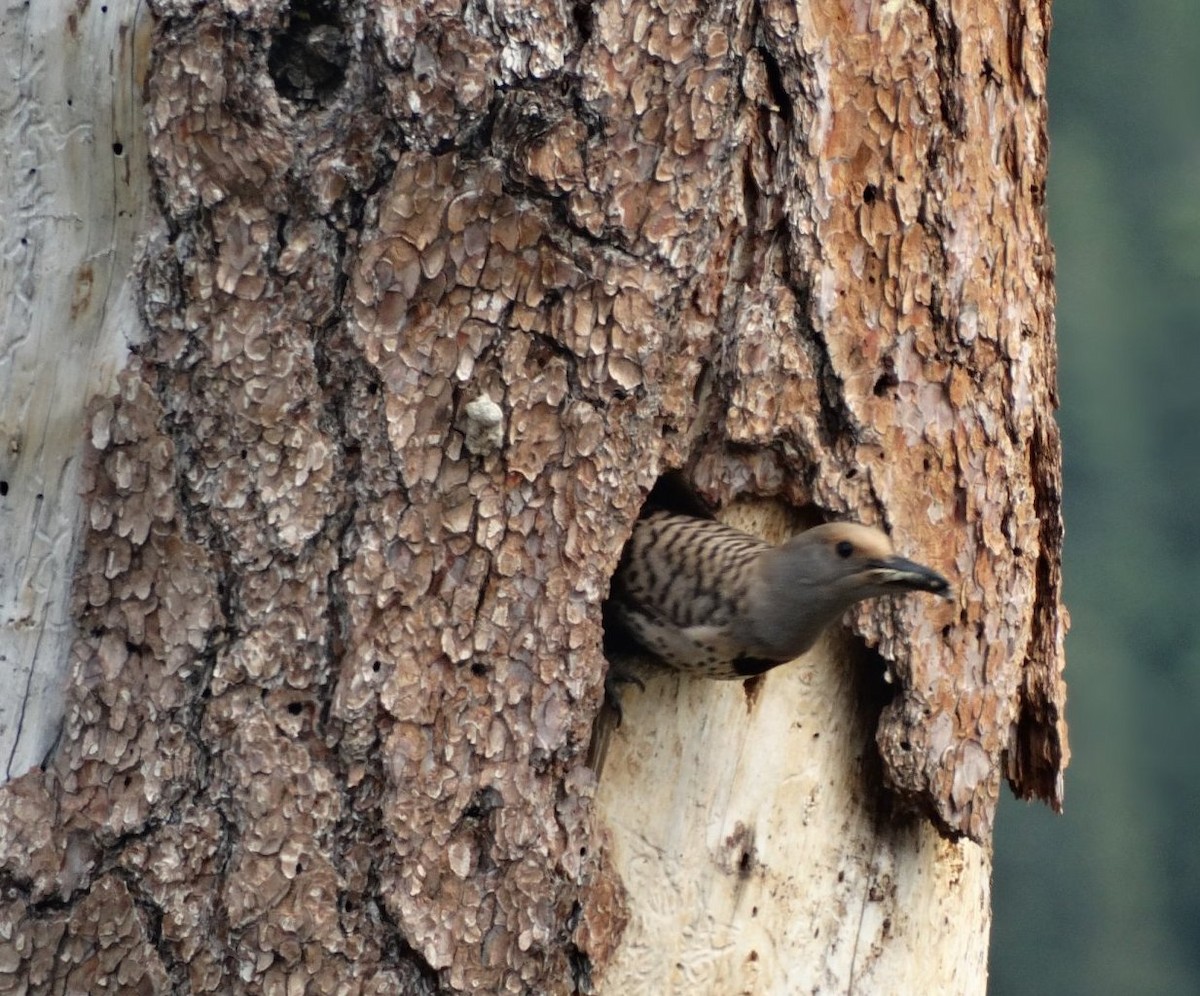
<box><xmin>989</xmin><ymin>0</ymin><xmax>1200</xmax><ymax>996</ymax></box>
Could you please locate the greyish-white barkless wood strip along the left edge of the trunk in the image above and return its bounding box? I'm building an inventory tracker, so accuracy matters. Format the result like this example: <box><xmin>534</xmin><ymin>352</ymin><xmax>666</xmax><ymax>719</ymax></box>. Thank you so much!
<box><xmin>0</xmin><ymin>0</ymin><xmax>152</xmax><ymax>778</ymax></box>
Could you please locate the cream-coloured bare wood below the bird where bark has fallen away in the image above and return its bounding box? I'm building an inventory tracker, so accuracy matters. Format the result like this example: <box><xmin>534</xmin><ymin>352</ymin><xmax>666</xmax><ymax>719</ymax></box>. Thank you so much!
<box><xmin>596</xmin><ymin>506</ymin><xmax>991</xmax><ymax>996</ymax></box>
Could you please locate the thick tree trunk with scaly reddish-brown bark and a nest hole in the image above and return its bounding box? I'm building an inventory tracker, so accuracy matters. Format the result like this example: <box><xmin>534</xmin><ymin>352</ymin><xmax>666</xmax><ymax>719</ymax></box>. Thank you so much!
<box><xmin>0</xmin><ymin>0</ymin><xmax>1067</xmax><ymax>994</ymax></box>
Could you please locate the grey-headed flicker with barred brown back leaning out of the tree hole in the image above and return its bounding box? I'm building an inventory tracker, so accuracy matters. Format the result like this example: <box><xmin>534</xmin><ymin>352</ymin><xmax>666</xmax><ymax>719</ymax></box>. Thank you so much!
<box><xmin>606</xmin><ymin>511</ymin><xmax>949</xmax><ymax>691</ymax></box>
